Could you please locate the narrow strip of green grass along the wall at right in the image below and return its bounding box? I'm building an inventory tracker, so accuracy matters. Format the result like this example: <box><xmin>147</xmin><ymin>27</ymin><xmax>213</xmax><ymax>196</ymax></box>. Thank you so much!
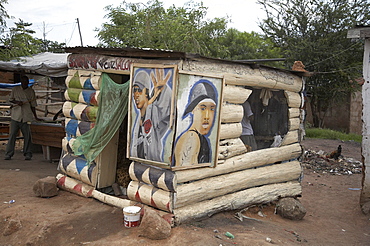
<box><xmin>306</xmin><ymin>128</ymin><xmax>362</xmax><ymax>143</ymax></box>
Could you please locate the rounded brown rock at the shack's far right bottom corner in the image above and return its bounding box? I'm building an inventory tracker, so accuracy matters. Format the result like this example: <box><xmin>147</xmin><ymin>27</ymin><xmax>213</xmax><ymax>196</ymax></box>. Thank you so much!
<box><xmin>276</xmin><ymin>197</ymin><xmax>306</xmax><ymax>220</ymax></box>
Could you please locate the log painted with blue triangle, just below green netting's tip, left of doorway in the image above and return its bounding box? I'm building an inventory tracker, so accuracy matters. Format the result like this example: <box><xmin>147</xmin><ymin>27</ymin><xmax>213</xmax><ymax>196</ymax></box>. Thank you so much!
<box><xmin>59</xmin><ymin>154</ymin><xmax>98</xmax><ymax>187</ymax></box>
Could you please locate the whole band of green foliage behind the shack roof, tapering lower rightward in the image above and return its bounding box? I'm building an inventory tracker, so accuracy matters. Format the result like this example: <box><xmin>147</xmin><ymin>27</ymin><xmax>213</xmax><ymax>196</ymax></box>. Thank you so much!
<box><xmin>96</xmin><ymin>0</ymin><xmax>281</xmax><ymax>60</ymax></box>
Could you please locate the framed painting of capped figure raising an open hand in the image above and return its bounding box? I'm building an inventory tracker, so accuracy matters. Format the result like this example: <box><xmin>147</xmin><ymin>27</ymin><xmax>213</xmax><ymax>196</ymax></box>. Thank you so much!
<box><xmin>127</xmin><ymin>64</ymin><xmax>177</xmax><ymax>168</ymax></box>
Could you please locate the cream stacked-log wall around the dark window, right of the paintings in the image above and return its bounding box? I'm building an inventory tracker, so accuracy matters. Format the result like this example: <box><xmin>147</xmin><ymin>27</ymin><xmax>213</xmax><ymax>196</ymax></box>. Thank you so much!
<box><xmin>127</xmin><ymin>61</ymin><xmax>303</xmax><ymax>224</ymax></box>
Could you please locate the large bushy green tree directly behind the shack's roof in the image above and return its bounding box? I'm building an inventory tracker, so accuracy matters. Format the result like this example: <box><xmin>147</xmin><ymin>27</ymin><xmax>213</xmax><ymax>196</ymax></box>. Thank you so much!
<box><xmin>97</xmin><ymin>0</ymin><xmax>228</xmax><ymax>56</ymax></box>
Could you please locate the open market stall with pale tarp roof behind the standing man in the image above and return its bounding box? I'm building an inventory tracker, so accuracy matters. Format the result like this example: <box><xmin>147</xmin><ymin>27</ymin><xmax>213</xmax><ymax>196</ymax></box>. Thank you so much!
<box><xmin>0</xmin><ymin>52</ymin><xmax>68</xmax><ymax>161</ymax></box>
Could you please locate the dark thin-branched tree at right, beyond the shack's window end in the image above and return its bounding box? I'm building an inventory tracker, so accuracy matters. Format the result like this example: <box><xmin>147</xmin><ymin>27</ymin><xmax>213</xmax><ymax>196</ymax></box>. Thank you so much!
<box><xmin>258</xmin><ymin>0</ymin><xmax>370</xmax><ymax>127</ymax></box>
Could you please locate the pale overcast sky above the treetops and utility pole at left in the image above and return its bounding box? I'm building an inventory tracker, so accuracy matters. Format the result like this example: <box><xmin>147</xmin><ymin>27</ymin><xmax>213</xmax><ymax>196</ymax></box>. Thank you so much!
<box><xmin>5</xmin><ymin>0</ymin><xmax>264</xmax><ymax>47</ymax></box>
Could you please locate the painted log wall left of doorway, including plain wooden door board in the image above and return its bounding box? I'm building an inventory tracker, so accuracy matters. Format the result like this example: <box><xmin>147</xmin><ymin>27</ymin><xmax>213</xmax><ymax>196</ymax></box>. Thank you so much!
<box><xmin>58</xmin><ymin>69</ymin><xmax>118</xmax><ymax>188</ymax></box>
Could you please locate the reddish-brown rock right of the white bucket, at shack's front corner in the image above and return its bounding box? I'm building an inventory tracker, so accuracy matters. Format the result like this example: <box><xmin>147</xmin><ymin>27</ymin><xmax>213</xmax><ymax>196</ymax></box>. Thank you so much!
<box><xmin>139</xmin><ymin>207</ymin><xmax>171</xmax><ymax>240</ymax></box>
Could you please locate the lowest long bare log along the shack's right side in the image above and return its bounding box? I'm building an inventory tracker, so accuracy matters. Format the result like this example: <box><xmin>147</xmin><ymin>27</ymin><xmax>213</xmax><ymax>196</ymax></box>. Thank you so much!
<box><xmin>174</xmin><ymin>182</ymin><xmax>302</xmax><ymax>225</ymax></box>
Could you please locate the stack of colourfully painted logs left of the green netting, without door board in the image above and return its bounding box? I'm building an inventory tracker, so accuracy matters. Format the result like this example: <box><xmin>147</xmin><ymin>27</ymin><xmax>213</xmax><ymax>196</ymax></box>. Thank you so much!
<box><xmin>59</xmin><ymin>69</ymin><xmax>101</xmax><ymax>187</ymax></box>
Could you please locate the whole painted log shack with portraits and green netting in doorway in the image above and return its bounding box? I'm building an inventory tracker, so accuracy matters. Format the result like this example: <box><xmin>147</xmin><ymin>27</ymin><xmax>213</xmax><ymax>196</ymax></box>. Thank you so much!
<box><xmin>57</xmin><ymin>47</ymin><xmax>304</xmax><ymax>225</ymax></box>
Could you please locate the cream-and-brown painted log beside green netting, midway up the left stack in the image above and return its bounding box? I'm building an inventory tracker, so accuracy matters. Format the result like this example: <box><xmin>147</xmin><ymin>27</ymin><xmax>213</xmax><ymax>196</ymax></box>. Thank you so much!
<box><xmin>63</xmin><ymin>101</ymin><xmax>98</xmax><ymax>121</ymax></box>
